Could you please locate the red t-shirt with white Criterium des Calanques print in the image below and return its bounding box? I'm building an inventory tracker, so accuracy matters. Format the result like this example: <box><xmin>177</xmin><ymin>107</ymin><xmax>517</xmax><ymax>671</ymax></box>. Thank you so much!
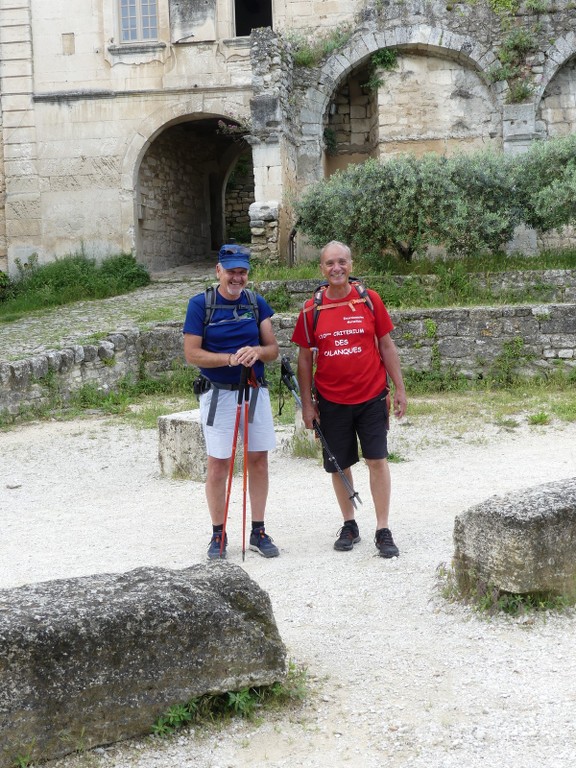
<box><xmin>292</xmin><ymin>287</ymin><xmax>394</xmax><ymax>405</ymax></box>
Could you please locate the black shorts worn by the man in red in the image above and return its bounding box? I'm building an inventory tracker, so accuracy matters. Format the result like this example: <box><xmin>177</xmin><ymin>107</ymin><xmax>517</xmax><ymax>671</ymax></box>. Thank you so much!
<box><xmin>318</xmin><ymin>389</ymin><xmax>388</xmax><ymax>472</ymax></box>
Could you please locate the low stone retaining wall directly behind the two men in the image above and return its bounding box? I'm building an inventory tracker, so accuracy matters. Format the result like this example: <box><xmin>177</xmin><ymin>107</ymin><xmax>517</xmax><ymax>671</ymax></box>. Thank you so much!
<box><xmin>0</xmin><ymin>304</ymin><xmax>576</xmax><ymax>415</ymax></box>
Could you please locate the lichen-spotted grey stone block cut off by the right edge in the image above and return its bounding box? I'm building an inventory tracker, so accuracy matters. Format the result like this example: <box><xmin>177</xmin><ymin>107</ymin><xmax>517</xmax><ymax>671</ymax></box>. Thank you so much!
<box><xmin>454</xmin><ymin>478</ymin><xmax>576</xmax><ymax>595</ymax></box>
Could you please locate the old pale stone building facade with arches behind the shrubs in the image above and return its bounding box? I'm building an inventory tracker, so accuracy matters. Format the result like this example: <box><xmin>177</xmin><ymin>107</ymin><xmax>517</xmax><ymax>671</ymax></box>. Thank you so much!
<box><xmin>0</xmin><ymin>0</ymin><xmax>576</xmax><ymax>274</ymax></box>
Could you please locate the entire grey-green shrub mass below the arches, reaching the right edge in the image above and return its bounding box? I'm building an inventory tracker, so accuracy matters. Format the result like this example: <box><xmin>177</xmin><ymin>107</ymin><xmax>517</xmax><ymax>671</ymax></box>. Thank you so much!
<box><xmin>295</xmin><ymin>136</ymin><xmax>576</xmax><ymax>262</ymax></box>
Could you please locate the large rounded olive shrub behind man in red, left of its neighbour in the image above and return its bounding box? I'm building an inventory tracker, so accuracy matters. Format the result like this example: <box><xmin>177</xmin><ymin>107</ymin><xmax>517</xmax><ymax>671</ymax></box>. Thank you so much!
<box><xmin>295</xmin><ymin>154</ymin><xmax>515</xmax><ymax>261</ymax></box>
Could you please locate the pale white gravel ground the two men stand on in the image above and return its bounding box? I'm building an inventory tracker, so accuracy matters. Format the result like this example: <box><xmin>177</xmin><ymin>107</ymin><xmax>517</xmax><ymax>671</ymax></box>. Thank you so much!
<box><xmin>0</xmin><ymin>408</ymin><xmax>576</xmax><ymax>768</ymax></box>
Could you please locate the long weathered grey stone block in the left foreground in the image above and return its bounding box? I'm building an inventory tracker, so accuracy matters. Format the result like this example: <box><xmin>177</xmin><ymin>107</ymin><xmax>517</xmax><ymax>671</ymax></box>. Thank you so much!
<box><xmin>0</xmin><ymin>562</ymin><xmax>286</xmax><ymax>768</ymax></box>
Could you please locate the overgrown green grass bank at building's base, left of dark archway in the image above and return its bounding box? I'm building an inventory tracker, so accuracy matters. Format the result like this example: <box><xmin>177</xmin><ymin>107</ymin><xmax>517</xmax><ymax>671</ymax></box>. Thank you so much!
<box><xmin>0</xmin><ymin>253</ymin><xmax>150</xmax><ymax>323</ymax></box>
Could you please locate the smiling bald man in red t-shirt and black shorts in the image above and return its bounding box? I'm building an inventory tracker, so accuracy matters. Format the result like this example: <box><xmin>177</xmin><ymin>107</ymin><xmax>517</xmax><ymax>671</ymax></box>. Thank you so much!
<box><xmin>292</xmin><ymin>240</ymin><xmax>406</xmax><ymax>557</ymax></box>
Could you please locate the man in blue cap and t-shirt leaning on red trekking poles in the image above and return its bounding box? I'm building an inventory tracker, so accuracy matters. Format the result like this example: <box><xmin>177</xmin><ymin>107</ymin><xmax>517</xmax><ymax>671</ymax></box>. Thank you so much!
<box><xmin>183</xmin><ymin>245</ymin><xmax>279</xmax><ymax>560</ymax></box>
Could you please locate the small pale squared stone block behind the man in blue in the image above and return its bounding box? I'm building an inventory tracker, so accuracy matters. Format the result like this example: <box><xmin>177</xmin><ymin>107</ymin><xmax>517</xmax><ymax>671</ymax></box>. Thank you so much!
<box><xmin>158</xmin><ymin>409</ymin><xmax>207</xmax><ymax>482</ymax></box>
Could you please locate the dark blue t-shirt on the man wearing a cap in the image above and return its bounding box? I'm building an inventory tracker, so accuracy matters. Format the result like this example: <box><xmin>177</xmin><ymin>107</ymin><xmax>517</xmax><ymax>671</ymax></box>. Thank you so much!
<box><xmin>183</xmin><ymin>291</ymin><xmax>274</xmax><ymax>384</ymax></box>
